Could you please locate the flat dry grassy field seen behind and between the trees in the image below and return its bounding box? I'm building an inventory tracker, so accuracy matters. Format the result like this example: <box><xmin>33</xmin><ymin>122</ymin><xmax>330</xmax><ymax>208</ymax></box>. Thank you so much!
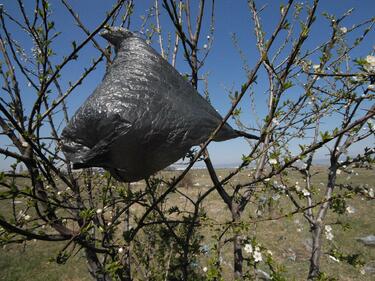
<box><xmin>0</xmin><ymin>167</ymin><xmax>375</xmax><ymax>281</ymax></box>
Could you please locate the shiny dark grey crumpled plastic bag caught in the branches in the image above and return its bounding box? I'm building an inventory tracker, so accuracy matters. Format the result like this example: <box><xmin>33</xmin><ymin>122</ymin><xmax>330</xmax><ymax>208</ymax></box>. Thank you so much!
<box><xmin>61</xmin><ymin>28</ymin><xmax>253</xmax><ymax>182</ymax></box>
